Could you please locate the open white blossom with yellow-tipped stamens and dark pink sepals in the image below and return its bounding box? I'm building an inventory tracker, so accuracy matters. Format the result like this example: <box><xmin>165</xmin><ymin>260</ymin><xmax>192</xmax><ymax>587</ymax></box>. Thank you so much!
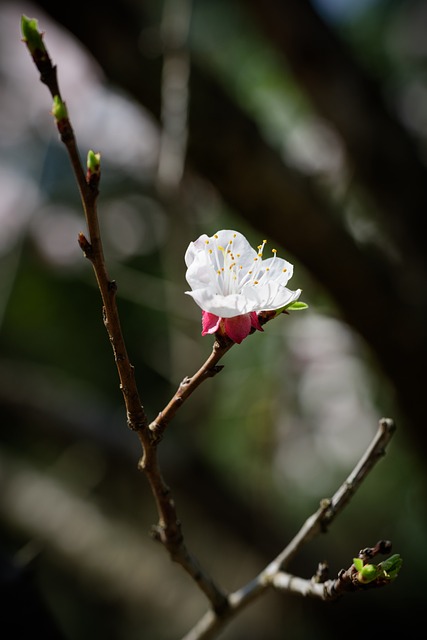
<box><xmin>185</xmin><ymin>229</ymin><xmax>301</xmax><ymax>342</ymax></box>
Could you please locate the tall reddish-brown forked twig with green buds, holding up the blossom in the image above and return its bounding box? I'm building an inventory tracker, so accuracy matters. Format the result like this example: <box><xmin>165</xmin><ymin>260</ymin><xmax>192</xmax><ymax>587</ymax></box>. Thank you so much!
<box><xmin>23</xmin><ymin>21</ymin><xmax>227</xmax><ymax>613</ymax></box>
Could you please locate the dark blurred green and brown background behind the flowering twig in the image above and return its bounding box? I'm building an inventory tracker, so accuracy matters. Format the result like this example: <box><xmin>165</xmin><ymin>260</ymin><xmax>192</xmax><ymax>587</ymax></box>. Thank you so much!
<box><xmin>0</xmin><ymin>0</ymin><xmax>427</xmax><ymax>640</ymax></box>
